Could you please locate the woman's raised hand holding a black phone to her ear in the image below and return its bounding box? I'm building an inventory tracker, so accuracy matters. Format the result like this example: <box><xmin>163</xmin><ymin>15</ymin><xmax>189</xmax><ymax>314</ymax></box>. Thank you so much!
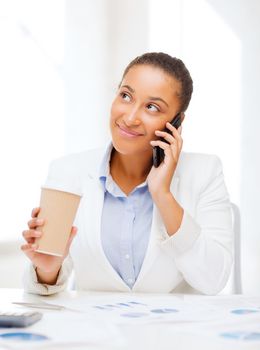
<box><xmin>147</xmin><ymin>123</ymin><xmax>183</xmax><ymax>197</ymax></box>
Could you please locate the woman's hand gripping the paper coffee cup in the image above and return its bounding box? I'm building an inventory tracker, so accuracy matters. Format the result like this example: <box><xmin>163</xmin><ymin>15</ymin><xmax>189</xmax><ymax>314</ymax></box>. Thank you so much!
<box><xmin>21</xmin><ymin>208</ymin><xmax>77</xmax><ymax>284</ymax></box>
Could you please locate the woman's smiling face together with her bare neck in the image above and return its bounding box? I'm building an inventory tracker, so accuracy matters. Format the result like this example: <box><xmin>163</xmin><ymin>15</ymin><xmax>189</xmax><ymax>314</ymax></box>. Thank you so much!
<box><xmin>110</xmin><ymin>63</ymin><xmax>183</xmax><ymax>194</ymax></box>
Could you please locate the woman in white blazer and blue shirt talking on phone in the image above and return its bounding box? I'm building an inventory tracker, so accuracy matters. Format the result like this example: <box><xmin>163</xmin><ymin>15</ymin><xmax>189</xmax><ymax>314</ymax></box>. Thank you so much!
<box><xmin>21</xmin><ymin>53</ymin><xmax>232</xmax><ymax>294</ymax></box>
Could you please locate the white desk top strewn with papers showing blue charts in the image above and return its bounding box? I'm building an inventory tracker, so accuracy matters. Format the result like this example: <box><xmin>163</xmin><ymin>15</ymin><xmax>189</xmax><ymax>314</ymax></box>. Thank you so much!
<box><xmin>0</xmin><ymin>289</ymin><xmax>260</xmax><ymax>350</ymax></box>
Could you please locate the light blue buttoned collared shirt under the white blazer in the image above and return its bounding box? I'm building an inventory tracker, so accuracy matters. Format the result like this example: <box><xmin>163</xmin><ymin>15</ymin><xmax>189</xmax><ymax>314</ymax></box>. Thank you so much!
<box><xmin>99</xmin><ymin>145</ymin><xmax>153</xmax><ymax>288</ymax></box>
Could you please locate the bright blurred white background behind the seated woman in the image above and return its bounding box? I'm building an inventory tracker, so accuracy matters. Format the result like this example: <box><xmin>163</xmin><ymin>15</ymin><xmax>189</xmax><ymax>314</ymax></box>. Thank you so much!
<box><xmin>0</xmin><ymin>0</ymin><xmax>260</xmax><ymax>293</ymax></box>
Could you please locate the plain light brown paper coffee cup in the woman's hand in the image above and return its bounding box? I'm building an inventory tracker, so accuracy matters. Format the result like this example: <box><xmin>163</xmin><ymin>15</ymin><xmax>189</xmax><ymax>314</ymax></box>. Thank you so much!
<box><xmin>36</xmin><ymin>188</ymin><xmax>81</xmax><ymax>256</ymax></box>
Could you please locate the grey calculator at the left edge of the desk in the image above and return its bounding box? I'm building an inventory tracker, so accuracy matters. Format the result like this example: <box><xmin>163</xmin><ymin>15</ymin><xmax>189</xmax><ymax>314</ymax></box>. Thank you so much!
<box><xmin>0</xmin><ymin>311</ymin><xmax>42</xmax><ymax>328</ymax></box>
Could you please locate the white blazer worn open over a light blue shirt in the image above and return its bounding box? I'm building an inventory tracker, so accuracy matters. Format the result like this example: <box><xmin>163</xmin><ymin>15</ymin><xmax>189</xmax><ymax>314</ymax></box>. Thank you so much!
<box><xmin>24</xmin><ymin>149</ymin><xmax>233</xmax><ymax>294</ymax></box>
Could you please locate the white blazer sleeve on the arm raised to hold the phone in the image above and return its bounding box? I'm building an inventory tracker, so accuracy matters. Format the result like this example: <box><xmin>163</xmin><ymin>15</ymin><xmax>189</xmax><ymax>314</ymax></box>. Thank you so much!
<box><xmin>162</xmin><ymin>156</ymin><xmax>233</xmax><ymax>295</ymax></box>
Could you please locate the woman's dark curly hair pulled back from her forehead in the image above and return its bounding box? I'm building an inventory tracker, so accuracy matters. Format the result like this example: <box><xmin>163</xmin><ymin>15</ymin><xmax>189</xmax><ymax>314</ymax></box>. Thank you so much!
<box><xmin>120</xmin><ymin>52</ymin><xmax>193</xmax><ymax>112</ymax></box>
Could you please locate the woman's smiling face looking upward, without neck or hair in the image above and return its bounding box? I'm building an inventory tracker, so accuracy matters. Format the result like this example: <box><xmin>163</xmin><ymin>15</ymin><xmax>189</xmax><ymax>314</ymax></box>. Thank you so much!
<box><xmin>110</xmin><ymin>65</ymin><xmax>180</xmax><ymax>155</ymax></box>
